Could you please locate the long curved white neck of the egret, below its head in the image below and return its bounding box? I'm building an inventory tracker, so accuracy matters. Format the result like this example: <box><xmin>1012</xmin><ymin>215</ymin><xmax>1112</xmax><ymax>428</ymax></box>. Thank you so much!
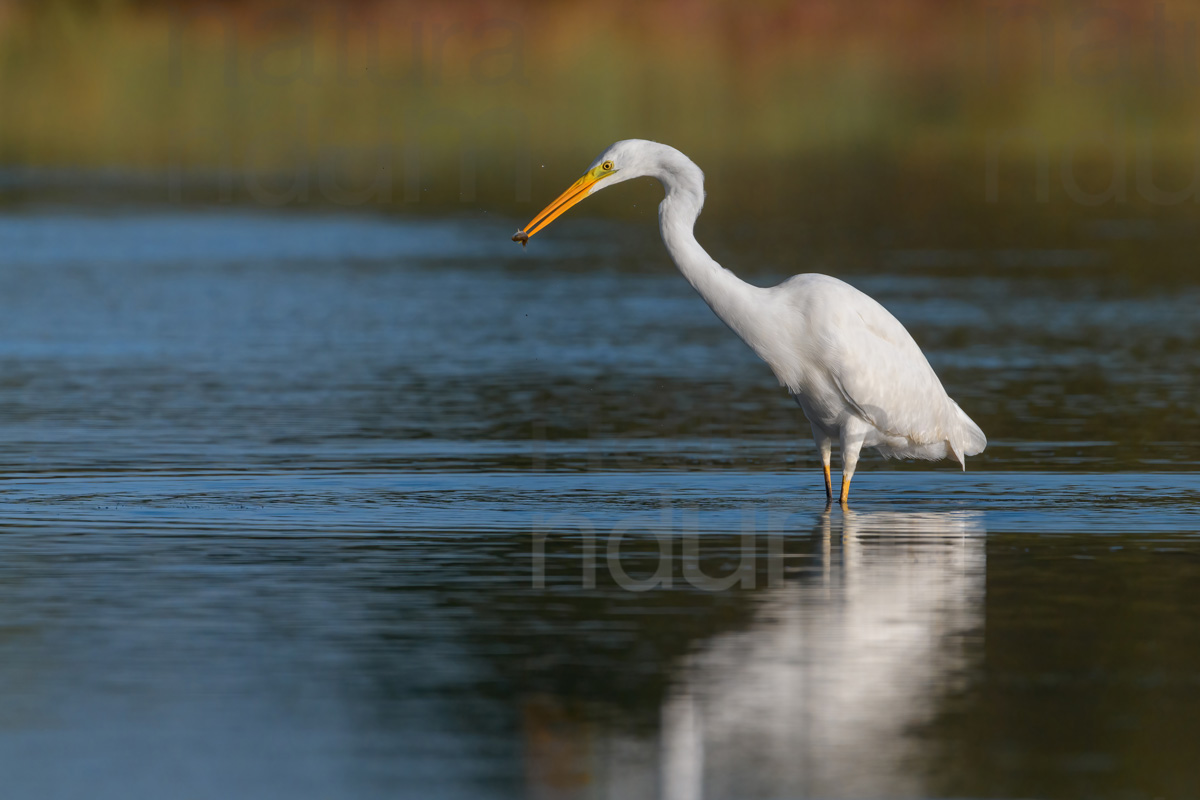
<box><xmin>659</xmin><ymin>185</ymin><xmax>768</xmax><ymax>357</ymax></box>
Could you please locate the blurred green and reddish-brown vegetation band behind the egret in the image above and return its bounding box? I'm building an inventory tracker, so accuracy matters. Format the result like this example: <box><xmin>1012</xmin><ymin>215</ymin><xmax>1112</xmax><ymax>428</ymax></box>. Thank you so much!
<box><xmin>0</xmin><ymin>0</ymin><xmax>1200</xmax><ymax>281</ymax></box>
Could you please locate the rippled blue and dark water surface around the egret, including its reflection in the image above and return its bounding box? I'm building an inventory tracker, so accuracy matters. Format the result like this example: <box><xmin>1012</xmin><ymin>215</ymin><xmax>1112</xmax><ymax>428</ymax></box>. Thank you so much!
<box><xmin>0</xmin><ymin>207</ymin><xmax>1200</xmax><ymax>799</ymax></box>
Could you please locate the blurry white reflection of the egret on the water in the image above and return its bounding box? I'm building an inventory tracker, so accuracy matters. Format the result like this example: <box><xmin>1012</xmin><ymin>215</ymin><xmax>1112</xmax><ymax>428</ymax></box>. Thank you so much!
<box><xmin>527</xmin><ymin>511</ymin><xmax>986</xmax><ymax>800</ymax></box>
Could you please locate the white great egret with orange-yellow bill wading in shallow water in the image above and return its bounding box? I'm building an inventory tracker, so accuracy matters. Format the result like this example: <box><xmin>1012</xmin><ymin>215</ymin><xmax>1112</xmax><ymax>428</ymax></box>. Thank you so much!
<box><xmin>512</xmin><ymin>139</ymin><xmax>988</xmax><ymax>504</ymax></box>
